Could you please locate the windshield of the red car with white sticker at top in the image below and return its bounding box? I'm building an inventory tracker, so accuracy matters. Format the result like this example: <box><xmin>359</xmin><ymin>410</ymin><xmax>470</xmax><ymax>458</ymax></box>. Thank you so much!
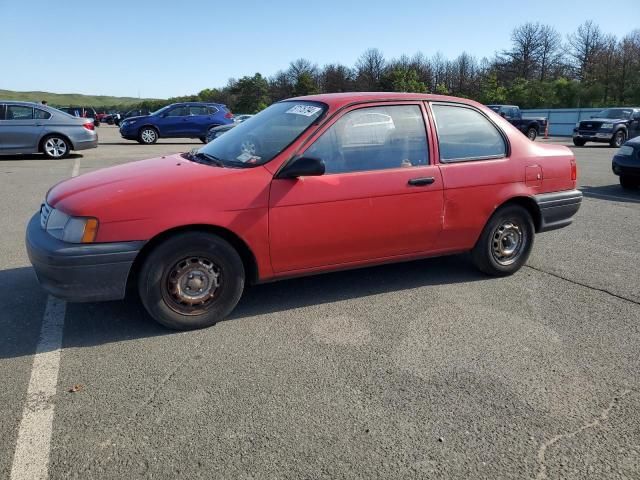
<box><xmin>199</xmin><ymin>101</ymin><xmax>326</xmax><ymax>167</ymax></box>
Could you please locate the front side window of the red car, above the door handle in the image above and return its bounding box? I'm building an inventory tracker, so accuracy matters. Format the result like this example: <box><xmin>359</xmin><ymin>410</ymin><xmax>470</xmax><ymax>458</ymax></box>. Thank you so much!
<box><xmin>304</xmin><ymin>105</ymin><xmax>429</xmax><ymax>174</ymax></box>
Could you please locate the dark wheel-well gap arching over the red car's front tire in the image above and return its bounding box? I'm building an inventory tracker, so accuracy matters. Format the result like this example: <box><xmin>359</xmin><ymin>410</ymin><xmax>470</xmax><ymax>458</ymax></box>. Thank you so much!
<box><xmin>127</xmin><ymin>225</ymin><xmax>258</xmax><ymax>289</ymax></box>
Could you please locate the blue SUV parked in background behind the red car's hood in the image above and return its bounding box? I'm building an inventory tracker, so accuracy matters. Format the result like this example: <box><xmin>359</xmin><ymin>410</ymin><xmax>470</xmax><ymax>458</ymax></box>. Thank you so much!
<box><xmin>120</xmin><ymin>102</ymin><xmax>233</xmax><ymax>145</ymax></box>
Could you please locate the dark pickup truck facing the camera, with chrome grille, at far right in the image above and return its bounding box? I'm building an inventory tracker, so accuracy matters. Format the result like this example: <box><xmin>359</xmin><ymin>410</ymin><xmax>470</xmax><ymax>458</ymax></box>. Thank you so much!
<box><xmin>573</xmin><ymin>107</ymin><xmax>640</xmax><ymax>147</ymax></box>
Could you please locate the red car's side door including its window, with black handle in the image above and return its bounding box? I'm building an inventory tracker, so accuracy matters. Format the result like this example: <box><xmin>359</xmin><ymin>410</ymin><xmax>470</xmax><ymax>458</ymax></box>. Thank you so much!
<box><xmin>269</xmin><ymin>103</ymin><xmax>443</xmax><ymax>273</ymax></box>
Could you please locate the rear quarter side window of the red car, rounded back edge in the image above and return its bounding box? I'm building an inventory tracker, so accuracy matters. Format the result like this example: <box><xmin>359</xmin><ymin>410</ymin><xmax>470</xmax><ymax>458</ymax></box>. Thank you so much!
<box><xmin>431</xmin><ymin>104</ymin><xmax>507</xmax><ymax>162</ymax></box>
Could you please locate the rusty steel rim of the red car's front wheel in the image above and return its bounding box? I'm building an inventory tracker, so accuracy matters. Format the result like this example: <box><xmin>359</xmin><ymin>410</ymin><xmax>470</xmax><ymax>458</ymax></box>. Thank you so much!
<box><xmin>162</xmin><ymin>255</ymin><xmax>222</xmax><ymax>315</ymax></box>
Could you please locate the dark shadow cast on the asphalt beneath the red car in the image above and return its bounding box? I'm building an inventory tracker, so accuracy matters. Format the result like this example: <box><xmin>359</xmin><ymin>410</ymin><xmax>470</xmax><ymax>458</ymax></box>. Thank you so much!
<box><xmin>0</xmin><ymin>255</ymin><xmax>480</xmax><ymax>359</ymax></box>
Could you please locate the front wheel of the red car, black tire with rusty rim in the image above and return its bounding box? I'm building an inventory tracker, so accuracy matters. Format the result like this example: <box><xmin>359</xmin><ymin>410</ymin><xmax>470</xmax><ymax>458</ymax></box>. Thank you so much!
<box><xmin>138</xmin><ymin>232</ymin><xmax>245</xmax><ymax>330</ymax></box>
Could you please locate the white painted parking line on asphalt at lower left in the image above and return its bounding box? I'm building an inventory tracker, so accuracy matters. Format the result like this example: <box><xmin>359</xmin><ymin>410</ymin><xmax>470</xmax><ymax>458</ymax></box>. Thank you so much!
<box><xmin>11</xmin><ymin>296</ymin><xmax>66</xmax><ymax>480</ymax></box>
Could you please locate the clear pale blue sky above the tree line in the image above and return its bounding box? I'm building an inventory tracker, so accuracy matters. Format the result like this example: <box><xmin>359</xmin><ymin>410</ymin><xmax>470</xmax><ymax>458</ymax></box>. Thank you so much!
<box><xmin>0</xmin><ymin>0</ymin><xmax>640</xmax><ymax>98</ymax></box>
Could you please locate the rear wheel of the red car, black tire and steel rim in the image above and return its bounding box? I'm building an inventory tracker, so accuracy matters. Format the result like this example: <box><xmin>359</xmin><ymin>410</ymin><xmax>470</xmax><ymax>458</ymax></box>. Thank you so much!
<box><xmin>471</xmin><ymin>205</ymin><xmax>535</xmax><ymax>277</ymax></box>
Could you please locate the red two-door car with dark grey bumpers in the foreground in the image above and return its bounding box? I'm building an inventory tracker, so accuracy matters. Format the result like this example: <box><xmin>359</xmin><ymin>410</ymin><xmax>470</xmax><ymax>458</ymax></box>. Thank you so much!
<box><xmin>26</xmin><ymin>93</ymin><xmax>582</xmax><ymax>329</ymax></box>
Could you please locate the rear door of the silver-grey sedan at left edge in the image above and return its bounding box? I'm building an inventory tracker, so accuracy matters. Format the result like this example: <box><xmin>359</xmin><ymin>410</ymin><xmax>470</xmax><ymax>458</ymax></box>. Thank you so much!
<box><xmin>0</xmin><ymin>103</ymin><xmax>43</xmax><ymax>153</ymax></box>
